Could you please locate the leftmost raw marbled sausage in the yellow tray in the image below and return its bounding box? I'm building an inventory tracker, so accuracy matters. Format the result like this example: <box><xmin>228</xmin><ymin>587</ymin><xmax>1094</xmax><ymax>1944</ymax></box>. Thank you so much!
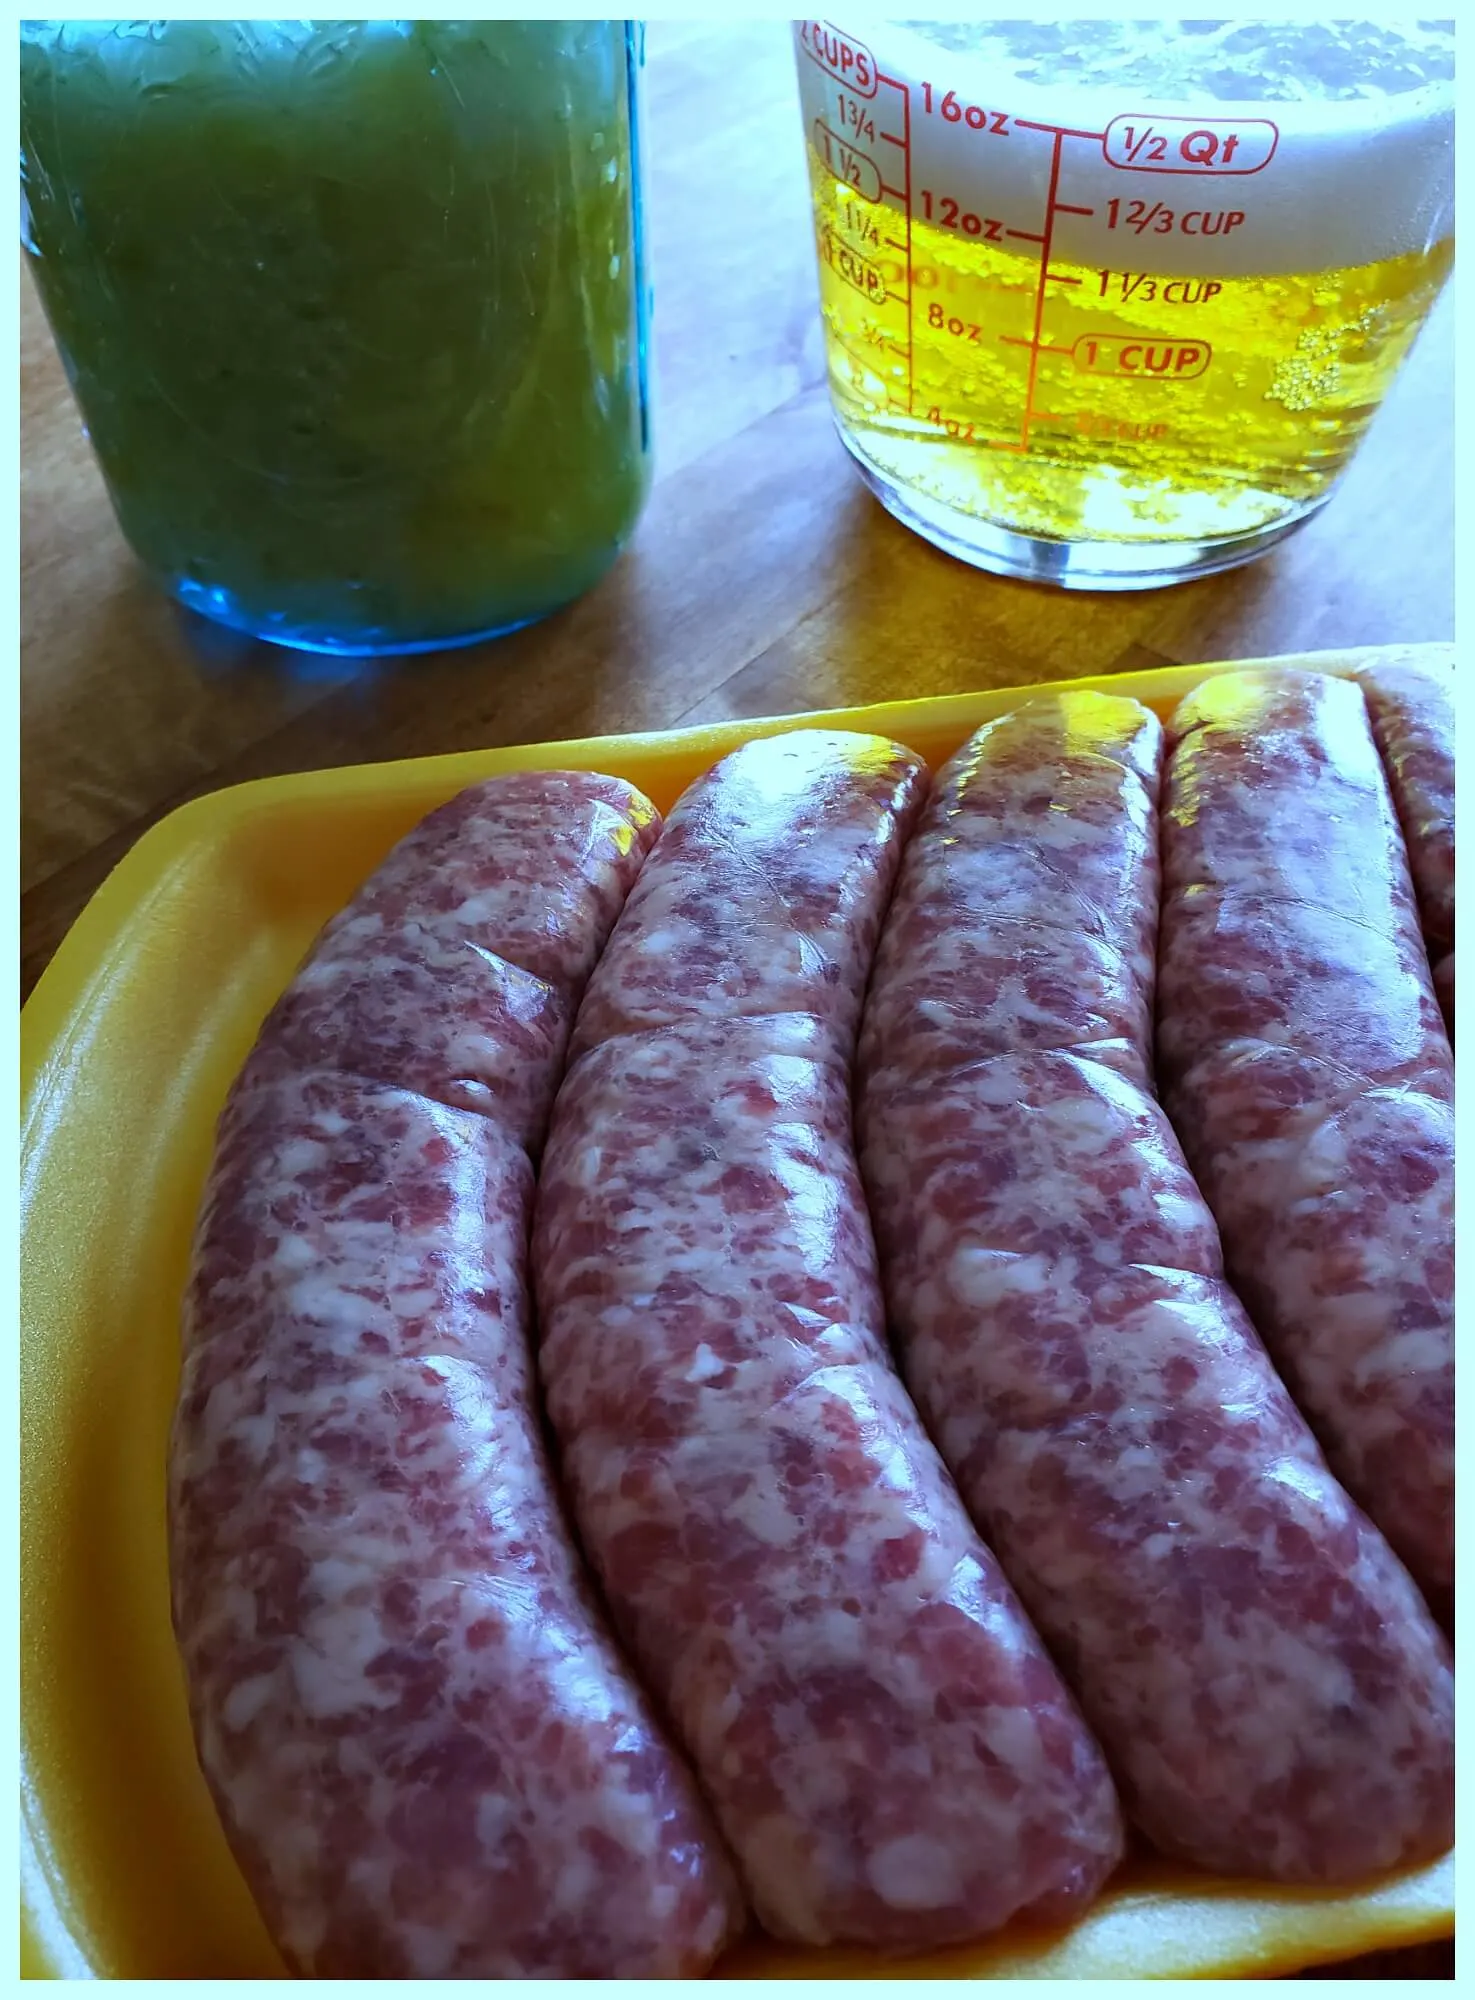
<box><xmin>170</xmin><ymin>774</ymin><xmax>741</xmax><ymax>1978</ymax></box>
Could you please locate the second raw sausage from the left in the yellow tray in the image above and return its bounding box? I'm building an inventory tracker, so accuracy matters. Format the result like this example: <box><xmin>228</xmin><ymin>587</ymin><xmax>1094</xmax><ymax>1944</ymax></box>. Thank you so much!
<box><xmin>534</xmin><ymin>732</ymin><xmax>1121</xmax><ymax>1950</ymax></box>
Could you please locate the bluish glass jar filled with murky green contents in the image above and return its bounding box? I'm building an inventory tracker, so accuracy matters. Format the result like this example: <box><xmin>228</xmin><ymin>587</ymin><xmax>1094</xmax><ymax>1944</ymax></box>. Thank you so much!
<box><xmin>20</xmin><ymin>20</ymin><xmax>650</xmax><ymax>654</ymax></box>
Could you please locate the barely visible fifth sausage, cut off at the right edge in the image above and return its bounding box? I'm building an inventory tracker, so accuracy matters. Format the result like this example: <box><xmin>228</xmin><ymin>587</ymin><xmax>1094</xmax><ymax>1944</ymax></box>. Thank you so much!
<box><xmin>1353</xmin><ymin>652</ymin><xmax>1455</xmax><ymax>1038</ymax></box>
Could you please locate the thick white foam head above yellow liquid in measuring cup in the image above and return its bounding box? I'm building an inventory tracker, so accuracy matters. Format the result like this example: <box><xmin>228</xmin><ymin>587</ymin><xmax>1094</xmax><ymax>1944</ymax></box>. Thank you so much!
<box><xmin>799</xmin><ymin>16</ymin><xmax>1455</xmax><ymax>276</ymax></box>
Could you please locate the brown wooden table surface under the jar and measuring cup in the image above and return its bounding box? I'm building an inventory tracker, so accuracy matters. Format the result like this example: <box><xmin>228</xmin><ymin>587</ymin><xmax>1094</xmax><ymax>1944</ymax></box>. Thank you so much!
<box><xmin>22</xmin><ymin>22</ymin><xmax>1453</xmax><ymax>1978</ymax></box>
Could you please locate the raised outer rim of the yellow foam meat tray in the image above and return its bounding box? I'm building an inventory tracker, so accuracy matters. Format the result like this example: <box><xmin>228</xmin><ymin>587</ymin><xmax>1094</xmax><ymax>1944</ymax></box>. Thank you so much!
<box><xmin>18</xmin><ymin>640</ymin><xmax>1455</xmax><ymax>1978</ymax></box>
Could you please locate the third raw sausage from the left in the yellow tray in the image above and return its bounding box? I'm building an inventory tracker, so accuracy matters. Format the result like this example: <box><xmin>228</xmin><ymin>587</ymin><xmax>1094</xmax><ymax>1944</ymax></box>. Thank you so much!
<box><xmin>857</xmin><ymin>694</ymin><xmax>1453</xmax><ymax>1882</ymax></box>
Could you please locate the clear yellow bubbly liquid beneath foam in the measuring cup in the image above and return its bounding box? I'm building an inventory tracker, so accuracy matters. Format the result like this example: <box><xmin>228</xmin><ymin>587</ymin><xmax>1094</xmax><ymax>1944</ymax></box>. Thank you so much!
<box><xmin>815</xmin><ymin>200</ymin><xmax>1453</xmax><ymax>540</ymax></box>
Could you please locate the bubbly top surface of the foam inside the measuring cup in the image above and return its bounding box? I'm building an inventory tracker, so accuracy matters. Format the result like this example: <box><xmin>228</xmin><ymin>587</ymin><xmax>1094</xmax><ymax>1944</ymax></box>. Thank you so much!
<box><xmin>899</xmin><ymin>20</ymin><xmax>1455</xmax><ymax>104</ymax></box>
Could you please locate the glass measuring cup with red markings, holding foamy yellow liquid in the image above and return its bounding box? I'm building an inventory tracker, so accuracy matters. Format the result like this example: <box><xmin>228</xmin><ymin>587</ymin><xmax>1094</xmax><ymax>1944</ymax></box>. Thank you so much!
<box><xmin>793</xmin><ymin>20</ymin><xmax>1453</xmax><ymax>590</ymax></box>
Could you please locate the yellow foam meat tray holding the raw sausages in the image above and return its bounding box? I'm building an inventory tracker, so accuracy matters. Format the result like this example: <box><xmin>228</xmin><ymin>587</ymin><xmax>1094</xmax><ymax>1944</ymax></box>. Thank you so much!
<box><xmin>20</xmin><ymin>648</ymin><xmax>1455</xmax><ymax>1978</ymax></box>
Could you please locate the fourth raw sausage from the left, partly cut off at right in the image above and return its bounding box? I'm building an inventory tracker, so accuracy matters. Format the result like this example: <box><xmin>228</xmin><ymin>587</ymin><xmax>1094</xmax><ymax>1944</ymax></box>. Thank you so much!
<box><xmin>1157</xmin><ymin>670</ymin><xmax>1455</xmax><ymax>1612</ymax></box>
